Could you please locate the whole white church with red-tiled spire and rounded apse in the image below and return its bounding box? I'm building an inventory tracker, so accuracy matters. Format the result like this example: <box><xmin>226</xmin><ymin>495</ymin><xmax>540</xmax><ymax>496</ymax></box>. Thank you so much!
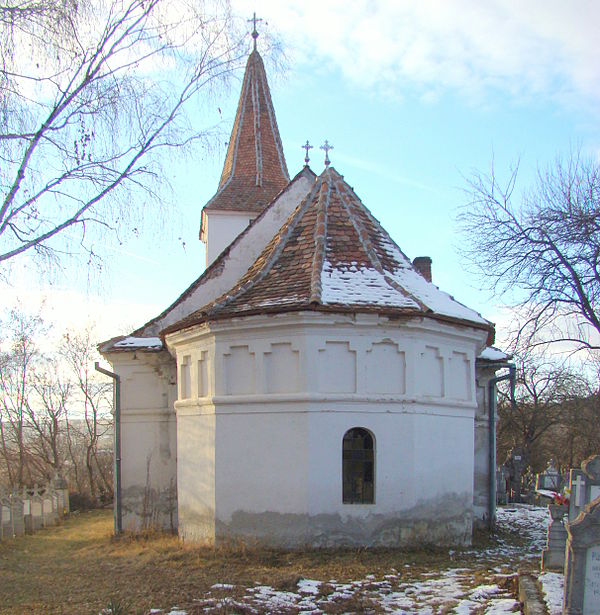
<box><xmin>99</xmin><ymin>39</ymin><xmax>506</xmax><ymax>547</ymax></box>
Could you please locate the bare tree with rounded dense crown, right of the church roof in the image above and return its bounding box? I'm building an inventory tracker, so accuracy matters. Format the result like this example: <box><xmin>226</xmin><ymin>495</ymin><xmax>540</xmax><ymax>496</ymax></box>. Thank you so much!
<box><xmin>461</xmin><ymin>154</ymin><xmax>600</xmax><ymax>351</ymax></box>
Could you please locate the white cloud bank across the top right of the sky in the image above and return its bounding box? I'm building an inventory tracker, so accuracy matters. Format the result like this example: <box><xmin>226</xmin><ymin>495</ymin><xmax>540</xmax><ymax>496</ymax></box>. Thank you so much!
<box><xmin>233</xmin><ymin>0</ymin><xmax>600</xmax><ymax>103</ymax></box>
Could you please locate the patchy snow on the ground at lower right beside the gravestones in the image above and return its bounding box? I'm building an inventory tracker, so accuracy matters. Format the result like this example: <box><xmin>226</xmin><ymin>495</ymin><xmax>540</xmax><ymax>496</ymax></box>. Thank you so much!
<box><xmin>148</xmin><ymin>505</ymin><xmax>562</xmax><ymax>615</ymax></box>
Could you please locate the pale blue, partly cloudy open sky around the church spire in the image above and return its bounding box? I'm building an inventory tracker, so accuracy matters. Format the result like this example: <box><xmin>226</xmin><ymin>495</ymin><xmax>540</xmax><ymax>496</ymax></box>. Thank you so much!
<box><xmin>0</xmin><ymin>0</ymin><xmax>600</xmax><ymax>348</ymax></box>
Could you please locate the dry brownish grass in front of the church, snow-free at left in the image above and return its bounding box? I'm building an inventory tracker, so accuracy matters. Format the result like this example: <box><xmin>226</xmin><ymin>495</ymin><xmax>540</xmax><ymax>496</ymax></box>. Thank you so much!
<box><xmin>0</xmin><ymin>511</ymin><xmax>516</xmax><ymax>615</ymax></box>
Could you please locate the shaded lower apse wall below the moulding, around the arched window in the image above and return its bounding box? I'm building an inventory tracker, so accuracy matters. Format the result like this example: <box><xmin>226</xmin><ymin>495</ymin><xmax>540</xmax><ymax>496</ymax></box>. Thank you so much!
<box><xmin>191</xmin><ymin>400</ymin><xmax>473</xmax><ymax>546</ymax></box>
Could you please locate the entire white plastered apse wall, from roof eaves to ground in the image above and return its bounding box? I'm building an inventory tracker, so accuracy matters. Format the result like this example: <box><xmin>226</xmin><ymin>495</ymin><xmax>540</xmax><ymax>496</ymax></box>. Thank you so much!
<box><xmin>168</xmin><ymin>313</ymin><xmax>486</xmax><ymax>546</ymax></box>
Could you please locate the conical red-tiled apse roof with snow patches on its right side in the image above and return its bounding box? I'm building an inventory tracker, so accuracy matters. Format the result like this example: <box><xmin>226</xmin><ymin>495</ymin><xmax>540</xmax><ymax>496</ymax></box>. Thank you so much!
<box><xmin>163</xmin><ymin>167</ymin><xmax>493</xmax><ymax>340</ymax></box>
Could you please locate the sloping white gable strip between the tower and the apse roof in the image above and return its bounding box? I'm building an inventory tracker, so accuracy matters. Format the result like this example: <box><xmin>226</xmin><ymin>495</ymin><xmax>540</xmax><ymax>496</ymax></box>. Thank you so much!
<box><xmin>144</xmin><ymin>176</ymin><xmax>314</xmax><ymax>335</ymax></box>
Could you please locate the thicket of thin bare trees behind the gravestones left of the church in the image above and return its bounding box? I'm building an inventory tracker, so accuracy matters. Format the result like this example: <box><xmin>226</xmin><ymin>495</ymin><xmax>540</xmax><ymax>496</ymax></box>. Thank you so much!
<box><xmin>0</xmin><ymin>312</ymin><xmax>112</xmax><ymax>505</ymax></box>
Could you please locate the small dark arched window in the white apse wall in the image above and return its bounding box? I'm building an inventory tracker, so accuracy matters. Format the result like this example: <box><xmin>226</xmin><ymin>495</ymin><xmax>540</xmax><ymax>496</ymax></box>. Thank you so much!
<box><xmin>342</xmin><ymin>427</ymin><xmax>375</xmax><ymax>504</ymax></box>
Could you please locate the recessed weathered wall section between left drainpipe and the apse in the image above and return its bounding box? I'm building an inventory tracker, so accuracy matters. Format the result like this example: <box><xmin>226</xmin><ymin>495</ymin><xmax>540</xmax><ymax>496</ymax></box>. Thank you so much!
<box><xmin>107</xmin><ymin>352</ymin><xmax>177</xmax><ymax>530</ymax></box>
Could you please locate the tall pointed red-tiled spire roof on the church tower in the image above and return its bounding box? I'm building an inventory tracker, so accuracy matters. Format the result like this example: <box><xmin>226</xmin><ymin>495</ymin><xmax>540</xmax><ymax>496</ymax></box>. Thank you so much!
<box><xmin>204</xmin><ymin>50</ymin><xmax>290</xmax><ymax>213</ymax></box>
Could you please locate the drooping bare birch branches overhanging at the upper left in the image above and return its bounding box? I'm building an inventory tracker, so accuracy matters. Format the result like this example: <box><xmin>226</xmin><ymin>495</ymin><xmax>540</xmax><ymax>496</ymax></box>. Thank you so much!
<box><xmin>0</xmin><ymin>0</ymin><xmax>242</xmax><ymax>270</ymax></box>
